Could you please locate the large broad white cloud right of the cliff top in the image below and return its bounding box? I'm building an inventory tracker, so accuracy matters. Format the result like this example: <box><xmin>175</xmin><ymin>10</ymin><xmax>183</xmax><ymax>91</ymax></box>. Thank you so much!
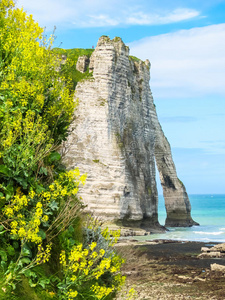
<box><xmin>130</xmin><ymin>23</ymin><xmax>225</xmax><ymax>97</ymax></box>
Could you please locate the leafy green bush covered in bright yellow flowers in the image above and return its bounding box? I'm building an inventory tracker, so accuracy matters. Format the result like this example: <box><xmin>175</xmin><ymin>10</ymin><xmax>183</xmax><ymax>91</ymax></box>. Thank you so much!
<box><xmin>0</xmin><ymin>0</ymin><xmax>125</xmax><ymax>300</ymax></box>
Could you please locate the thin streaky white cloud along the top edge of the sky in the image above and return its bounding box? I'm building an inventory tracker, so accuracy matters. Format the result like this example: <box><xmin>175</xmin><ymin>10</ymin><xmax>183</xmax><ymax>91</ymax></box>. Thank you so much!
<box><xmin>17</xmin><ymin>0</ymin><xmax>200</xmax><ymax>28</ymax></box>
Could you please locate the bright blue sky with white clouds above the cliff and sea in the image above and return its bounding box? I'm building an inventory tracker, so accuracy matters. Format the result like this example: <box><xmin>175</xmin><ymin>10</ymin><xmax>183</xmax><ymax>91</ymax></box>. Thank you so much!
<box><xmin>17</xmin><ymin>0</ymin><xmax>225</xmax><ymax>194</ymax></box>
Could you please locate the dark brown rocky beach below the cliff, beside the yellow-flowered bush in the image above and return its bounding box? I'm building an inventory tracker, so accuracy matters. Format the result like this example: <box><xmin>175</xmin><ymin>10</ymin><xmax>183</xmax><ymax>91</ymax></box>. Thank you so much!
<box><xmin>117</xmin><ymin>239</ymin><xmax>225</xmax><ymax>300</ymax></box>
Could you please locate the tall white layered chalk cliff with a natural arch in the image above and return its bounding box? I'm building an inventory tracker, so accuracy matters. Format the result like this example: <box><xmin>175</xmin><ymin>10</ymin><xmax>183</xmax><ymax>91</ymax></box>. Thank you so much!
<box><xmin>64</xmin><ymin>36</ymin><xmax>198</xmax><ymax>230</ymax></box>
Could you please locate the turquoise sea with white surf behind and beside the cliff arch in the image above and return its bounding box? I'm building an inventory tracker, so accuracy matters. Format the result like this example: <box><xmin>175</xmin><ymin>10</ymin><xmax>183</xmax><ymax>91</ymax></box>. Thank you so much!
<box><xmin>135</xmin><ymin>194</ymin><xmax>225</xmax><ymax>243</ymax></box>
